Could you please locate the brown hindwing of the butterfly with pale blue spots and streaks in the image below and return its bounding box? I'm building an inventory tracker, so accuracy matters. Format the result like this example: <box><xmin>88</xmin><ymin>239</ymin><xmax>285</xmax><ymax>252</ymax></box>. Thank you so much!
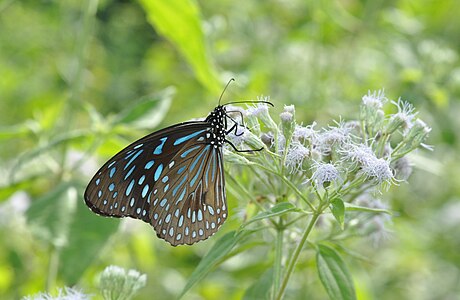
<box><xmin>151</xmin><ymin>143</ymin><xmax>227</xmax><ymax>245</ymax></box>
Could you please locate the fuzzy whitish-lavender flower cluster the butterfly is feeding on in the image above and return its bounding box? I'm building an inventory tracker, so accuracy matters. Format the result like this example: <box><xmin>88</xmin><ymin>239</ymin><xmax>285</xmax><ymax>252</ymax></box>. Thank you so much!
<box><xmin>227</xmin><ymin>90</ymin><xmax>431</xmax><ymax>243</ymax></box>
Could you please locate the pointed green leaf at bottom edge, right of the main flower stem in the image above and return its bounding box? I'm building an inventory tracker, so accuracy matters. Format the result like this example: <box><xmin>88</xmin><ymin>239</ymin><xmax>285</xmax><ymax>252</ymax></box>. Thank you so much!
<box><xmin>316</xmin><ymin>245</ymin><xmax>356</xmax><ymax>300</ymax></box>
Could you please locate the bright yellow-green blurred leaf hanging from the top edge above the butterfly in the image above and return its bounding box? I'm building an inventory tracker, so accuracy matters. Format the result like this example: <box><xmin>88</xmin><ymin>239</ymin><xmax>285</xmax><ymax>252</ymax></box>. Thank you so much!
<box><xmin>140</xmin><ymin>0</ymin><xmax>222</xmax><ymax>93</ymax></box>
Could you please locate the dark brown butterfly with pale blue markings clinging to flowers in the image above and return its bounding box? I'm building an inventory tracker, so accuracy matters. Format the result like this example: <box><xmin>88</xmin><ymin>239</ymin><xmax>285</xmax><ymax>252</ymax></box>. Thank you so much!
<box><xmin>84</xmin><ymin>82</ymin><xmax>273</xmax><ymax>246</ymax></box>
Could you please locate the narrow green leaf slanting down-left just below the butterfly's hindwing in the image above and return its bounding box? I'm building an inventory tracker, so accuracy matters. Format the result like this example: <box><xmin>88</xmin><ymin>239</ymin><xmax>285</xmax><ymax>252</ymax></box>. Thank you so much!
<box><xmin>179</xmin><ymin>231</ymin><xmax>249</xmax><ymax>298</ymax></box>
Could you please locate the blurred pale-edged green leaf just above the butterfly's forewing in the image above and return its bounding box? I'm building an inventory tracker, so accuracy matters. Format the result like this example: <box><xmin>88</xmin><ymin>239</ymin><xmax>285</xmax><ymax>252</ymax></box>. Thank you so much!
<box><xmin>114</xmin><ymin>88</ymin><xmax>175</xmax><ymax>129</ymax></box>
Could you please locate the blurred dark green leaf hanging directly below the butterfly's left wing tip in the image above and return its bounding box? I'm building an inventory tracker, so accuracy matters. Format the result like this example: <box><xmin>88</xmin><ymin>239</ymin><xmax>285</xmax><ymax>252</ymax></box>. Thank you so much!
<box><xmin>59</xmin><ymin>186</ymin><xmax>120</xmax><ymax>286</ymax></box>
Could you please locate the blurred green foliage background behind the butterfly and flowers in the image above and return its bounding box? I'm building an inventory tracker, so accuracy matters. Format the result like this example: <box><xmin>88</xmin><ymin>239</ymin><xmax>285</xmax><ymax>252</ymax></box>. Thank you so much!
<box><xmin>0</xmin><ymin>0</ymin><xmax>460</xmax><ymax>299</ymax></box>
